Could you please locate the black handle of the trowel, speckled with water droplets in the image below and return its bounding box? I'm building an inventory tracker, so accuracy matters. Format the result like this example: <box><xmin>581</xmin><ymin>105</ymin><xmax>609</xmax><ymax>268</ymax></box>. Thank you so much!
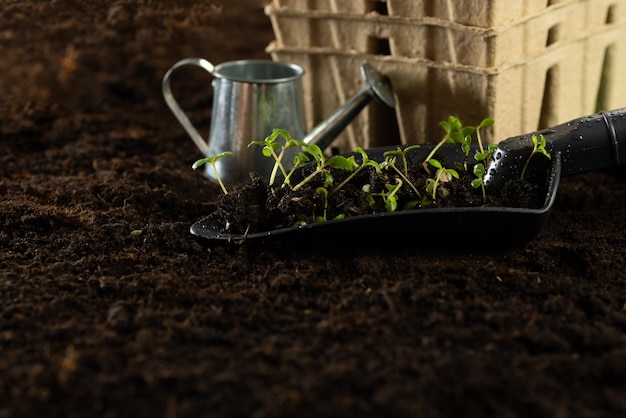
<box><xmin>535</xmin><ymin>108</ymin><xmax>626</xmax><ymax>176</ymax></box>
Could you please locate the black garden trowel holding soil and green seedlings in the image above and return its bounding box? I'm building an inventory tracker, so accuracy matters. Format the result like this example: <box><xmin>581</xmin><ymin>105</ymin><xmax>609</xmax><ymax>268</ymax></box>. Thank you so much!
<box><xmin>191</xmin><ymin>108</ymin><xmax>626</xmax><ymax>245</ymax></box>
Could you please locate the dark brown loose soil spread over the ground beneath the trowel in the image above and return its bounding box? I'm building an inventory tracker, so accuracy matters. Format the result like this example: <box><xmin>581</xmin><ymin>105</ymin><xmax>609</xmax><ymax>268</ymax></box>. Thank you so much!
<box><xmin>0</xmin><ymin>0</ymin><xmax>626</xmax><ymax>418</ymax></box>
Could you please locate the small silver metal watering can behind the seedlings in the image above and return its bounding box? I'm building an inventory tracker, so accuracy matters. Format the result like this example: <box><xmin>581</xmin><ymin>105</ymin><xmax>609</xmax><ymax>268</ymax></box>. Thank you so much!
<box><xmin>162</xmin><ymin>58</ymin><xmax>395</xmax><ymax>184</ymax></box>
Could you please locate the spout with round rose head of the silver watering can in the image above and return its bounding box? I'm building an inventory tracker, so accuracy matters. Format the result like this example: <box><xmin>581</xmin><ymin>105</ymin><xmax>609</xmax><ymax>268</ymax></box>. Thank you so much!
<box><xmin>302</xmin><ymin>63</ymin><xmax>395</xmax><ymax>150</ymax></box>
